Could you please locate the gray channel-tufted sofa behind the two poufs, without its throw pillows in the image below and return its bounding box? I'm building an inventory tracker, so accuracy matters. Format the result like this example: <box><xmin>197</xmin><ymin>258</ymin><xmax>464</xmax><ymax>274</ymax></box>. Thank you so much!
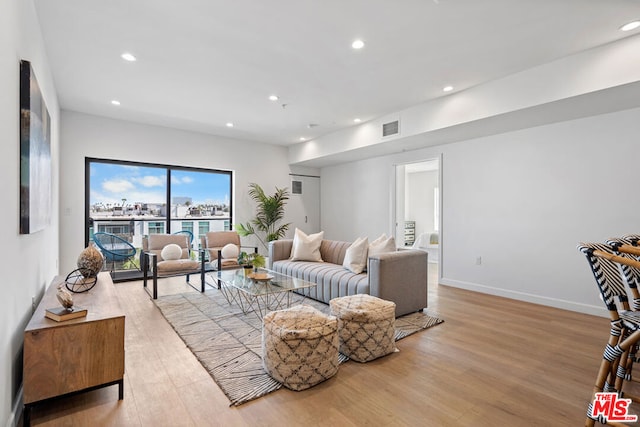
<box><xmin>268</xmin><ymin>239</ymin><xmax>427</xmax><ymax>317</ymax></box>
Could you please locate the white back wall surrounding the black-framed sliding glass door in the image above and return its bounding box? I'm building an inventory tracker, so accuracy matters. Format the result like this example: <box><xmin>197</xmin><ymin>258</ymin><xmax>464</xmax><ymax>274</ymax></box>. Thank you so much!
<box><xmin>60</xmin><ymin>111</ymin><xmax>318</xmax><ymax>273</ymax></box>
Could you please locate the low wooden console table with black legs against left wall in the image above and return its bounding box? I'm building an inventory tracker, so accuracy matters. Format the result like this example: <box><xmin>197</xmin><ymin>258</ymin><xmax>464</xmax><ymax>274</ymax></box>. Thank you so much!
<box><xmin>23</xmin><ymin>272</ymin><xmax>124</xmax><ymax>426</ymax></box>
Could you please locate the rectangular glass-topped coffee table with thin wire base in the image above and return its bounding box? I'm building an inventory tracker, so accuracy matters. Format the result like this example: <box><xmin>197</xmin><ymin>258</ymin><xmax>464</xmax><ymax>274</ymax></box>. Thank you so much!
<box><xmin>214</xmin><ymin>268</ymin><xmax>317</xmax><ymax>319</ymax></box>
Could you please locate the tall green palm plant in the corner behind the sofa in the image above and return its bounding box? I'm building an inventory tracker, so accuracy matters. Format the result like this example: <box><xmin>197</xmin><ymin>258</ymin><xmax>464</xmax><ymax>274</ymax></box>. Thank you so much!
<box><xmin>235</xmin><ymin>183</ymin><xmax>291</xmax><ymax>250</ymax></box>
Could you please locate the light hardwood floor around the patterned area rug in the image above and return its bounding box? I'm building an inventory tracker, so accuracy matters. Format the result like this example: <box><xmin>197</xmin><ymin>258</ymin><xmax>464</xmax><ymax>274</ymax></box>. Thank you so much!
<box><xmin>23</xmin><ymin>265</ymin><xmax>609</xmax><ymax>426</ymax></box>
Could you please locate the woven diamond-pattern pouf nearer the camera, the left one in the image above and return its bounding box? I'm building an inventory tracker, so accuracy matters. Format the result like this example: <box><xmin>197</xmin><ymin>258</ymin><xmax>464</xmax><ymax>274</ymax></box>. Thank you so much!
<box><xmin>262</xmin><ymin>305</ymin><xmax>339</xmax><ymax>391</ymax></box>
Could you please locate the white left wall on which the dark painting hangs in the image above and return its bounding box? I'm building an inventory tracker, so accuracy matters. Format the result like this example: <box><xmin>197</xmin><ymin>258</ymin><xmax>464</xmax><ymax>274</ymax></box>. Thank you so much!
<box><xmin>0</xmin><ymin>0</ymin><xmax>59</xmax><ymax>426</ymax></box>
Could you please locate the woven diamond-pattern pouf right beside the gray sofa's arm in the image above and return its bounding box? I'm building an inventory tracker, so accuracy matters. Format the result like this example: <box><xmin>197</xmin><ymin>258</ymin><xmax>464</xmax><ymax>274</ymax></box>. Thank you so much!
<box><xmin>329</xmin><ymin>294</ymin><xmax>396</xmax><ymax>362</ymax></box>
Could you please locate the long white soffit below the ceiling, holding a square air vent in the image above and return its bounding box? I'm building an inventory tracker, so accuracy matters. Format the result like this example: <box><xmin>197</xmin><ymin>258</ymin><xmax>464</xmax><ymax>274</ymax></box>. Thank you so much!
<box><xmin>289</xmin><ymin>35</ymin><xmax>640</xmax><ymax>166</ymax></box>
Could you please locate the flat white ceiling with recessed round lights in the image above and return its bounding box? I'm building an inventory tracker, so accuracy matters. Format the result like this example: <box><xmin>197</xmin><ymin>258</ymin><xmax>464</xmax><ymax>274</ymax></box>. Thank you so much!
<box><xmin>35</xmin><ymin>0</ymin><xmax>640</xmax><ymax>145</ymax></box>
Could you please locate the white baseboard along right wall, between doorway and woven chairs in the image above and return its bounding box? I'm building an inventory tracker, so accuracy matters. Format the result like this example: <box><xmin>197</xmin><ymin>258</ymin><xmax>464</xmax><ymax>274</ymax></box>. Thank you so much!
<box><xmin>440</xmin><ymin>277</ymin><xmax>609</xmax><ymax>318</ymax></box>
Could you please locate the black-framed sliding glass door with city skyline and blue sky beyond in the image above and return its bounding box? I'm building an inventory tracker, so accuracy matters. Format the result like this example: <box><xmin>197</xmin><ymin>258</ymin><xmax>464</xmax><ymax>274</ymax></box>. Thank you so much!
<box><xmin>85</xmin><ymin>159</ymin><xmax>232</xmax><ymax>273</ymax></box>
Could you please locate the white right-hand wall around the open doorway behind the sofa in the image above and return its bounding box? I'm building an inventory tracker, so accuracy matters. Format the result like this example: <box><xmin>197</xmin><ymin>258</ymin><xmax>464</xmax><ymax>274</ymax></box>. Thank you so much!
<box><xmin>322</xmin><ymin>109</ymin><xmax>640</xmax><ymax>314</ymax></box>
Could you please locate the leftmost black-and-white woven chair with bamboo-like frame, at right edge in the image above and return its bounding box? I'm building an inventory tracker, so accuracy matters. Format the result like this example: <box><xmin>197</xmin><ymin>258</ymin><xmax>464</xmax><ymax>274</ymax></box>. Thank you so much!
<box><xmin>578</xmin><ymin>243</ymin><xmax>640</xmax><ymax>426</ymax></box>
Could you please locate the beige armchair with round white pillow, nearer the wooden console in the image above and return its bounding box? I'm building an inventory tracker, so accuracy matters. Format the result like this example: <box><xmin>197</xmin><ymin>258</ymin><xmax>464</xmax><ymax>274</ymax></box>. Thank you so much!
<box><xmin>141</xmin><ymin>234</ymin><xmax>207</xmax><ymax>299</ymax></box>
